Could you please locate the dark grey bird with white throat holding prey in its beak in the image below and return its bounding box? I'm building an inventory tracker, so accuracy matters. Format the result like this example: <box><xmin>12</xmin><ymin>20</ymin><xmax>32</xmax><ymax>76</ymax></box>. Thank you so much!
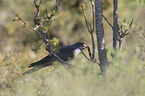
<box><xmin>23</xmin><ymin>42</ymin><xmax>88</xmax><ymax>74</ymax></box>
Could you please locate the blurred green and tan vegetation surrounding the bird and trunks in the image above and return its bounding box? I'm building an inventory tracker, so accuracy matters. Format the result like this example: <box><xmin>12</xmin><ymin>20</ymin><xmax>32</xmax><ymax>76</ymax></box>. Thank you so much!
<box><xmin>0</xmin><ymin>0</ymin><xmax>145</xmax><ymax>96</ymax></box>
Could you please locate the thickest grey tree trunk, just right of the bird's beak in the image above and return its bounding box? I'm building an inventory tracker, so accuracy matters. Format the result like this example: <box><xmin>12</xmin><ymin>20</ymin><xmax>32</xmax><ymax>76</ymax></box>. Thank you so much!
<box><xmin>95</xmin><ymin>0</ymin><xmax>109</xmax><ymax>73</ymax></box>
